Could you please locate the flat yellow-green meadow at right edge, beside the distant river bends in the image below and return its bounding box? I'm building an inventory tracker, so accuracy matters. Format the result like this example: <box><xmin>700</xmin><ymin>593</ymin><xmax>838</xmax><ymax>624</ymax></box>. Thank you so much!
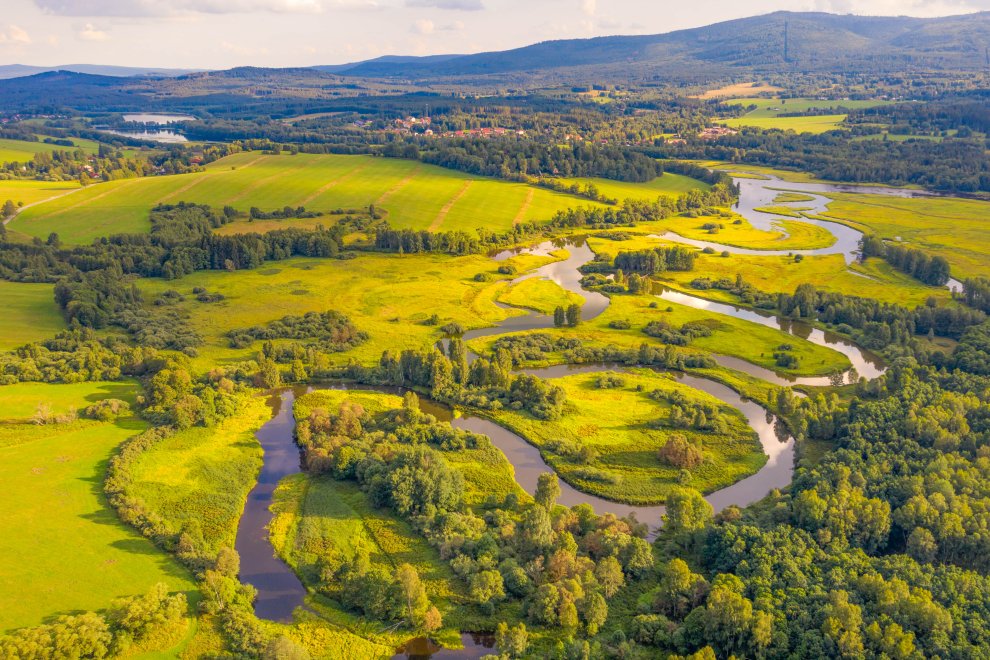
<box><xmin>828</xmin><ymin>193</ymin><xmax>990</xmax><ymax>279</ymax></box>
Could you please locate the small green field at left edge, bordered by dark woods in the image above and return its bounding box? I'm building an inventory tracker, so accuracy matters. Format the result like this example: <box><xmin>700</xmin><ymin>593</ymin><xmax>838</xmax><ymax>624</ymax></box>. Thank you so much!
<box><xmin>0</xmin><ymin>281</ymin><xmax>65</xmax><ymax>351</ymax></box>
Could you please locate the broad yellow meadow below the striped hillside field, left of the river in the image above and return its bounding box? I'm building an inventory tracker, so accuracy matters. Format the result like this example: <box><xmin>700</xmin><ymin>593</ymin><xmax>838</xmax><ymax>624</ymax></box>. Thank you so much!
<box><xmin>138</xmin><ymin>253</ymin><xmax>552</xmax><ymax>371</ymax></box>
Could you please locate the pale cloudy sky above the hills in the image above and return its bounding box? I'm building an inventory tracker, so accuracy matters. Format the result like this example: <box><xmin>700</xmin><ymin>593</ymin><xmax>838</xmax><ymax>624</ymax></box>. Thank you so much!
<box><xmin>0</xmin><ymin>0</ymin><xmax>990</xmax><ymax>69</ymax></box>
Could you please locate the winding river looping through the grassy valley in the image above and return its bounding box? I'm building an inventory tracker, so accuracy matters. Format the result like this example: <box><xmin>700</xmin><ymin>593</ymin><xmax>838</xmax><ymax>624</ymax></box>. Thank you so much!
<box><xmin>236</xmin><ymin>171</ymin><xmax>922</xmax><ymax>657</ymax></box>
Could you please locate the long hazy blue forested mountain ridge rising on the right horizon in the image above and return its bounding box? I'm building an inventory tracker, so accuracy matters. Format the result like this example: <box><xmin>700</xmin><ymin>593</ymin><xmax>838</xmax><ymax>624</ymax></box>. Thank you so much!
<box><xmin>326</xmin><ymin>12</ymin><xmax>990</xmax><ymax>79</ymax></box>
